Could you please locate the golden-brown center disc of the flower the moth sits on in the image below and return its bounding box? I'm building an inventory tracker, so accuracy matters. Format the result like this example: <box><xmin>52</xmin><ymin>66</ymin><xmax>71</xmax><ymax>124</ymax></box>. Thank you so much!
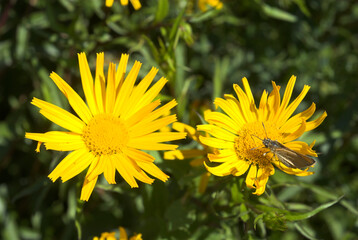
<box><xmin>235</xmin><ymin>122</ymin><xmax>283</xmax><ymax>167</ymax></box>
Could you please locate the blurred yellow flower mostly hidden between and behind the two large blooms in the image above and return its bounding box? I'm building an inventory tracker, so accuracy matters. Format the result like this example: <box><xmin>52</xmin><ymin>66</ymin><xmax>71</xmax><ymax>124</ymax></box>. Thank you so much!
<box><xmin>164</xmin><ymin>120</ymin><xmax>215</xmax><ymax>193</ymax></box>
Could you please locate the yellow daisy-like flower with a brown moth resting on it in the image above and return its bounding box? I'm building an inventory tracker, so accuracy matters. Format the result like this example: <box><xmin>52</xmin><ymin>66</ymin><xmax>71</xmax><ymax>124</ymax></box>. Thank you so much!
<box><xmin>198</xmin><ymin>76</ymin><xmax>327</xmax><ymax>195</ymax></box>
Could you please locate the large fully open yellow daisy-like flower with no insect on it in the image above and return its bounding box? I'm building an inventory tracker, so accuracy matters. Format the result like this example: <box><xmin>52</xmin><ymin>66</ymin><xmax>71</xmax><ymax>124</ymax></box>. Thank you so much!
<box><xmin>25</xmin><ymin>53</ymin><xmax>186</xmax><ymax>201</ymax></box>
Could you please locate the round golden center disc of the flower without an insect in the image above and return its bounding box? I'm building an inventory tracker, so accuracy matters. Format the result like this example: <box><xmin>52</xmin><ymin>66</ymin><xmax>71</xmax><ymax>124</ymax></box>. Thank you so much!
<box><xmin>82</xmin><ymin>113</ymin><xmax>129</xmax><ymax>156</ymax></box>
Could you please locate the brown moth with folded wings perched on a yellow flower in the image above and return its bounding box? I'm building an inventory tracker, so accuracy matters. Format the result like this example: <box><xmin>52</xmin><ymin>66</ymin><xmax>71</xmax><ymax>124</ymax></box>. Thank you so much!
<box><xmin>255</xmin><ymin>123</ymin><xmax>316</xmax><ymax>169</ymax></box>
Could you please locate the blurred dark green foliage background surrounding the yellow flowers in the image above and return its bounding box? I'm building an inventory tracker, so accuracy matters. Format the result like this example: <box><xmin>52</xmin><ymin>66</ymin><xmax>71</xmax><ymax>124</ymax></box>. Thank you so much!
<box><xmin>0</xmin><ymin>0</ymin><xmax>358</xmax><ymax>240</ymax></box>
